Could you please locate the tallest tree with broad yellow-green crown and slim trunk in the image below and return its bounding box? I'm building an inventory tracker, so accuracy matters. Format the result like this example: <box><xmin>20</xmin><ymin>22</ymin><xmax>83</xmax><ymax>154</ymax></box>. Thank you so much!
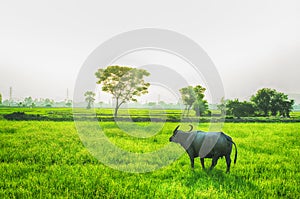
<box><xmin>95</xmin><ymin>66</ymin><xmax>150</xmax><ymax>117</ymax></box>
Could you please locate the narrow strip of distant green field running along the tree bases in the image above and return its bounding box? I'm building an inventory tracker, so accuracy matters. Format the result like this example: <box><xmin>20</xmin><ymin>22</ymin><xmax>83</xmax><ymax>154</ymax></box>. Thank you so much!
<box><xmin>0</xmin><ymin>107</ymin><xmax>300</xmax><ymax>123</ymax></box>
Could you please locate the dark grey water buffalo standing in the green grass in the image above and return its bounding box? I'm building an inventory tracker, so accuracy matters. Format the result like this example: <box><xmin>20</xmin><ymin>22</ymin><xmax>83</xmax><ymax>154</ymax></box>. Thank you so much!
<box><xmin>170</xmin><ymin>126</ymin><xmax>237</xmax><ymax>172</ymax></box>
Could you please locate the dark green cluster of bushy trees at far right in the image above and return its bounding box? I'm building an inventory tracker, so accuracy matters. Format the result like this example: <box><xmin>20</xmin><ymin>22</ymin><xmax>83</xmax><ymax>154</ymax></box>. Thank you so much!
<box><xmin>218</xmin><ymin>88</ymin><xmax>294</xmax><ymax>118</ymax></box>
